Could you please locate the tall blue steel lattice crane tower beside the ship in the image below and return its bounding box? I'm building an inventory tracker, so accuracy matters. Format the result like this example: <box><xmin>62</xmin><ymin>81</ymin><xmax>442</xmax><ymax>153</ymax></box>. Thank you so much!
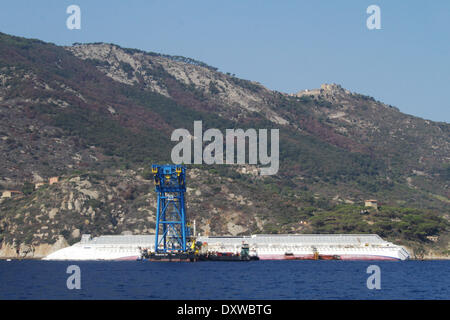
<box><xmin>152</xmin><ymin>164</ymin><xmax>190</xmax><ymax>253</ymax></box>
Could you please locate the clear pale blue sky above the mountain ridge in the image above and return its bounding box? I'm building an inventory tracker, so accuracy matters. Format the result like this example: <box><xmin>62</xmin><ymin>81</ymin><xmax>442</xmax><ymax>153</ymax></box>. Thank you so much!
<box><xmin>0</xmin><ymin>0</ymin><xmax>450</xmax><ymax>123</ymax></box>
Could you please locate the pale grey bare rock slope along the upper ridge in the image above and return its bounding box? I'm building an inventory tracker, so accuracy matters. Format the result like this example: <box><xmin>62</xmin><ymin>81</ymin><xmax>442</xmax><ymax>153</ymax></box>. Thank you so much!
<box><xmin>66</xmin><ymin>44</ymin><xmax>288</xmax><ymax>124</ymax></box>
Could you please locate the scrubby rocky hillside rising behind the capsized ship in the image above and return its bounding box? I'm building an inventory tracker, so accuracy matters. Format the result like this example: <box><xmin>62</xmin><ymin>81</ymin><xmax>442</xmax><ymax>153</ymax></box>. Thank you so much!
<box><xmin>0</xmin><ymin>34</ymin><xmax>450</xmax><ymax>256</ymax></box>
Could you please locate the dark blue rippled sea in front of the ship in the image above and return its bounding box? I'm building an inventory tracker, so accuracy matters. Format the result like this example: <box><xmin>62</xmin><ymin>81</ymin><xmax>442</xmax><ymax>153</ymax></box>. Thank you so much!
<box><xmin>0</xmin><ymin>261</ymin><xmax>450</xmax><ymax>299</ymax></box>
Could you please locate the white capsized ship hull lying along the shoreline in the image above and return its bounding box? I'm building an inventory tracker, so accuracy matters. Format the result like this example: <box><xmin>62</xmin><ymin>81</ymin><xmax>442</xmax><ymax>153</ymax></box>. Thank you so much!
<box><xmin>44</xmin><ymin>234</ymin><xmax>410</xmax><ymax>260</ymax></box>
